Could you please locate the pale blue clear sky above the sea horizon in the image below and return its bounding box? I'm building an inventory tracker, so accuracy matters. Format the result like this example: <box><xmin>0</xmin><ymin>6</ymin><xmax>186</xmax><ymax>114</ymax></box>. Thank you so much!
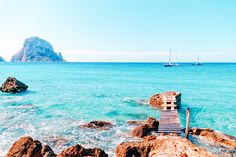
<box><xmin>0</xmin><ymin>0</ymin><xmax>236</xmax><ymax>62</ymax></box>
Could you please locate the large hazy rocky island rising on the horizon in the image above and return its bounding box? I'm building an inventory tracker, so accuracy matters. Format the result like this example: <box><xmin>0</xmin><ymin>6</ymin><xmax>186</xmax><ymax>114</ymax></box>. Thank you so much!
<box><xmin>11</xmin><ymin>37</ymin><xmax>65</xmax><ymax>62</ymax></box>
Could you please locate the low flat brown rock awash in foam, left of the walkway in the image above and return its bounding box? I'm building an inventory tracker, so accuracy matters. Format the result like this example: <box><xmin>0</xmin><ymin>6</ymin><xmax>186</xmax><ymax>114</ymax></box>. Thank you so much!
<box><xmin>80</xmin><ymin>121</ymin><xmax>112</xmax><ymax>130</ymax></box>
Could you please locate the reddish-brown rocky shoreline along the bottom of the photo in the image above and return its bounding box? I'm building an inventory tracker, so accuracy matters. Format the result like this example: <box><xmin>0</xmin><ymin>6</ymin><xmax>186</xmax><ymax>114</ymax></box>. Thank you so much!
<box><xmin>5</xmin><ymin>117</ymin><xmax>236</xmax><ymax>157</ymax></box>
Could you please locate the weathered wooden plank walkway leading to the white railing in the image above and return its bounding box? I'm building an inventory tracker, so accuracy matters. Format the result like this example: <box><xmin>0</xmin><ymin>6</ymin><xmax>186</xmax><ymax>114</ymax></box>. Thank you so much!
<box><xmin>158</xmin><ymin>110</ymin><xmax>181</xmax><ymax>133</ymax></box>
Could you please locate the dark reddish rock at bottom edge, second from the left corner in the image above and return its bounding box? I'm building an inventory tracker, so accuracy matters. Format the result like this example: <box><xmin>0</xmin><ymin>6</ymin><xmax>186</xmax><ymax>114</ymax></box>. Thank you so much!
<box><xmin>57</xmin><ymin>144</ymin><xmax>108</xmax><ymax>157</ymax></box>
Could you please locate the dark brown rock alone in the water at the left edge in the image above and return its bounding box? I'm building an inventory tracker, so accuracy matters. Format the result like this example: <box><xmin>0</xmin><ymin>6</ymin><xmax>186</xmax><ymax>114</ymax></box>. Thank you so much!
<box><xmin>0</xmin><ymin>77</ymin><xmax>28</xmax><ymax>93</ymax></box>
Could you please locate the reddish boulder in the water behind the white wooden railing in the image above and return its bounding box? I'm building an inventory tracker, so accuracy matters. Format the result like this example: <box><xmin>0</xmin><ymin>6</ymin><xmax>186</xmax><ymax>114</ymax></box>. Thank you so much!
<box><xmin>149</xmin><ymin>91</ymin><xmax>181</xmax><ymax>109</ymax></box>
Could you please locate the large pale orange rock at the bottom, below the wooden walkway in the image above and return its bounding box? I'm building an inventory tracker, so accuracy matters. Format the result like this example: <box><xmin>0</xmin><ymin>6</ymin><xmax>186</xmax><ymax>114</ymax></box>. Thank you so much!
<box><xmin>116</xmin><ymin>136</ymin><xmax>214</xmax><ymax>157</ymax></box>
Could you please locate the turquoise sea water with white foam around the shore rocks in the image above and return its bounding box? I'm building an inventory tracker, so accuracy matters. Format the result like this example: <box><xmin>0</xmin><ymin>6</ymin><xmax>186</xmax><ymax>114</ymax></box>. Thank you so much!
<box><xmin>0</xmin><ymin>63</ymin><xmax>236</xmax><ymax>156</ymax></box>
